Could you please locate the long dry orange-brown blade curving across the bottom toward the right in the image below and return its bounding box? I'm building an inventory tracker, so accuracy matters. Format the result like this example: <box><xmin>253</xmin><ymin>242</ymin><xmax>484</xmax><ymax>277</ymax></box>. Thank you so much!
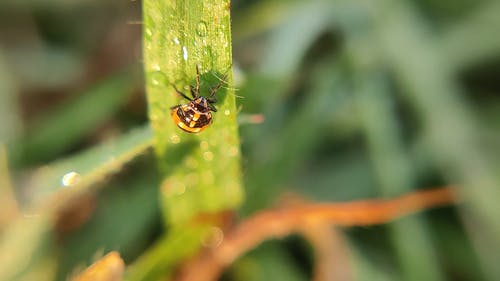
<box><xmin>176</xmin><ymin>188</ymin><xmax>457</xmax><ymax>281</ymax></box>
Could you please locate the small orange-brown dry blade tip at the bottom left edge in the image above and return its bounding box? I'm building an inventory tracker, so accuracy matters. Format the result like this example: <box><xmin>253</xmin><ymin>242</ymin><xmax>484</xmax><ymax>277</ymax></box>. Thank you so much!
<box><xmin>71</xmin><ymin>252</ymin><xmax>125</xmax><ymax>281</ymax></box>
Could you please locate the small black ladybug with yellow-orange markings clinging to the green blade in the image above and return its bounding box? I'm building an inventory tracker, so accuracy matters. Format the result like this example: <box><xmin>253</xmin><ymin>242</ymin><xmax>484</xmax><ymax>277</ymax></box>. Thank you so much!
<box><xmin>170</xmin><ymin>65</ymin><xmax>225</xmax><ymax>133</ymax></box>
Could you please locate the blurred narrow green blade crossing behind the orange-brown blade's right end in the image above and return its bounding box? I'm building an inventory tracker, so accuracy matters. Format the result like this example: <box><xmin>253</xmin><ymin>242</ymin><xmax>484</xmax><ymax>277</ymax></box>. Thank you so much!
<box><xmin>356</xmin><ymin>71</ymin><xmax>443</xmax><ymax>281</ymax></box>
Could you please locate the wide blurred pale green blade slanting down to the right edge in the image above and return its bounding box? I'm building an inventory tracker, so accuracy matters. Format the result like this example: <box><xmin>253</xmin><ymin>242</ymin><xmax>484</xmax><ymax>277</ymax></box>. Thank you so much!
<box><xmin>372</xmin><ymin>0</ymin><xmax>500</xmax><ymax>280</ymax></box>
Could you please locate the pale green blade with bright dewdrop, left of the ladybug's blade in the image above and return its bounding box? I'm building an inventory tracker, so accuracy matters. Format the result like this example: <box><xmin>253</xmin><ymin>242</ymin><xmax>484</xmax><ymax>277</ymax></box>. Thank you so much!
<box><xmin>0</xmin><ymin>126</ymin><xmax>152</xmax><ymax>280</ymax></box>
